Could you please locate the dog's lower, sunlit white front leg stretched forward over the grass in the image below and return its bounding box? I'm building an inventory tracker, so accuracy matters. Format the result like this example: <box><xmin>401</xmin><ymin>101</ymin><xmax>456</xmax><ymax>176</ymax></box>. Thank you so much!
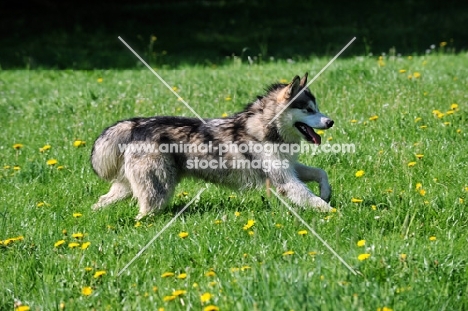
<box><xmin>273</xmin><ymin>177</ymin><xmax>332</xmax><ymax>212</ymax></box>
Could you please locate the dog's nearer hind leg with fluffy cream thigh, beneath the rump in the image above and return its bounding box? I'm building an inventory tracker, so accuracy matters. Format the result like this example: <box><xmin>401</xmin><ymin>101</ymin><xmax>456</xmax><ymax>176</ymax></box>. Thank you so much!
<box><xmin>125</xmin><ymin>155</ymin><xmax>177</xmax><ymax>220</ymax></box>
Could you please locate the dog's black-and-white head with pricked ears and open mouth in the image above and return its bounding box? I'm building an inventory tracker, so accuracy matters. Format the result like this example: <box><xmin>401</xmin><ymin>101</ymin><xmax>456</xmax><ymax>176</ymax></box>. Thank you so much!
<box><xmin>273</xmin><ymin>73</ymin><xmax>334</xmax><ymax>145</ymax></box>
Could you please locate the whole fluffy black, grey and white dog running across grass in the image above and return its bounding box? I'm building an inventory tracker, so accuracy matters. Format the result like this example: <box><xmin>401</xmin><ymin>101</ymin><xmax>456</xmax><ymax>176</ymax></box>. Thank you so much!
<box><xmin>91</xmin><ymin>73</ymin><xmax>333</xmax><ymax>219</ymax></box>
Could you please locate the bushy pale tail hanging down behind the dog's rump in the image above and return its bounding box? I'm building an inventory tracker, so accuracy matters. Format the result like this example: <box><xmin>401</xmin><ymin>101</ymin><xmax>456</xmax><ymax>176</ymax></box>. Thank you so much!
<box><xmin>91</xmin><ymin>121</ymin><xmax>133</xmax><ymax>181</ymax></box>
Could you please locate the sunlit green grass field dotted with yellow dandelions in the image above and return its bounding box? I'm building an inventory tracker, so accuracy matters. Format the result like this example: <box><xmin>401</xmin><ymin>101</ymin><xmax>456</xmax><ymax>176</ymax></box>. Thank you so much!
<box><xmin>0</xmin><ymin>54</ymin><xmax>468</xmax><ymax>311</ymax></box>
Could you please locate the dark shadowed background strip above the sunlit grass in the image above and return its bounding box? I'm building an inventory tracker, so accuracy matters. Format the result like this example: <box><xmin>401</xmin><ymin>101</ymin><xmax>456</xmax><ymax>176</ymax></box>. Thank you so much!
<box><xmin>0</xmin><ymin>0</ymin><xmax>468</xmax><ymax>69</ymax></box>
